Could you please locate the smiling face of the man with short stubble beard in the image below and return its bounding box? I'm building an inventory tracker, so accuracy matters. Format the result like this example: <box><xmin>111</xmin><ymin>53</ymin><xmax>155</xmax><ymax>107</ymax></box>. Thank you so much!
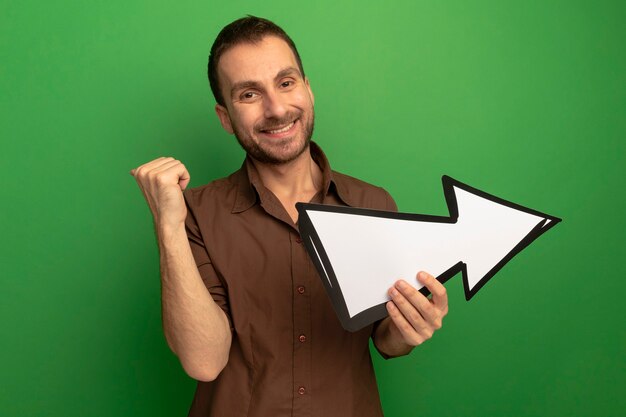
<box><xmin>215</xmin><ymin>36</ymin><xmax>314</xmax><ymax>164</ymax></box>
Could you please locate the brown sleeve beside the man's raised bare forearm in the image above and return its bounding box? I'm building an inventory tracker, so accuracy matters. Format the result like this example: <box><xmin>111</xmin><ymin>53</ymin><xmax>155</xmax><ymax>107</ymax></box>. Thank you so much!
<box><xmin>184</xmin><ymin>190</ymin><xmax>233</xmax><ymax>329</ymax></box>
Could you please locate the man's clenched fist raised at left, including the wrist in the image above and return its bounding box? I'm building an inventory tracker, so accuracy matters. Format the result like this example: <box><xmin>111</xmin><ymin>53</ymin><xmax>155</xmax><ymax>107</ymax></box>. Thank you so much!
<box><xmin>130</xmin><ymin>157</ymin><xmax>190</xmax><ymax>227</ymax></box>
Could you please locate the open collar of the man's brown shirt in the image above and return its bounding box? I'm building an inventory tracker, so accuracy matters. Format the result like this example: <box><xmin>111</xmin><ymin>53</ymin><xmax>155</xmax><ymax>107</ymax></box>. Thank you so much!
<box><xmin>232</xmin><ymin>142</ymin><xmax>354</xmax><ymax>213</ymax></box>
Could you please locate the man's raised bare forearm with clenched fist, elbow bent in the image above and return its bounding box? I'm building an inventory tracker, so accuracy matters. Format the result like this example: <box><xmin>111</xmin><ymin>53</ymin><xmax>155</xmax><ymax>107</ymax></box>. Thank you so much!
<box><xmin>130</xmin><ymin>158</ymin><xmax>232</xmax><ymax>381</ymax></box>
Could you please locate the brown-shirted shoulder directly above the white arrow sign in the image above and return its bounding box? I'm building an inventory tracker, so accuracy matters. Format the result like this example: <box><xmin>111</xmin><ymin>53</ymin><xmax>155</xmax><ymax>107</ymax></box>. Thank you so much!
<box><xmin>332</xmin><ymin>171</ymin><xmax>398</xmax><ymax>211</ymax></box>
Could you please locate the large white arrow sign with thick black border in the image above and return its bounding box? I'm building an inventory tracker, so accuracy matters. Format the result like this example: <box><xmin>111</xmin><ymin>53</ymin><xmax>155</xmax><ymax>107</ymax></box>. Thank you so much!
<box><xmin>297</xmin><ymin>176</ymin><xmax>561</xmax><ymax>331</ymax></box>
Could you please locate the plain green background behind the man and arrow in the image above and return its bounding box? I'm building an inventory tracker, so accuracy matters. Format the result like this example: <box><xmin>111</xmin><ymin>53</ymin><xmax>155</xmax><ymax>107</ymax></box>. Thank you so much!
<box><xmin>0</xmin><ymin>0</ymin><xmax>626</xmax><ymax>417</ymax></box>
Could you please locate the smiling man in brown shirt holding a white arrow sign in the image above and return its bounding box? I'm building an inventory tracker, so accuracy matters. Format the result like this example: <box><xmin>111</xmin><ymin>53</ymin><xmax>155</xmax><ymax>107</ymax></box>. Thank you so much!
<box><xmin>131</xmin><ymin>17</ymin><xmax>448</xmax><ymax>417</ymax></box>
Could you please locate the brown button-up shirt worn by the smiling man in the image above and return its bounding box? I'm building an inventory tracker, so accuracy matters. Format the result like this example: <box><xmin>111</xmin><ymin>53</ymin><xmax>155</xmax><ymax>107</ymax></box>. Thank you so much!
<box><xmin>185</xmin><ymin>143</ymin><xmax>396</xmax><ymax>417</ymax></box>
